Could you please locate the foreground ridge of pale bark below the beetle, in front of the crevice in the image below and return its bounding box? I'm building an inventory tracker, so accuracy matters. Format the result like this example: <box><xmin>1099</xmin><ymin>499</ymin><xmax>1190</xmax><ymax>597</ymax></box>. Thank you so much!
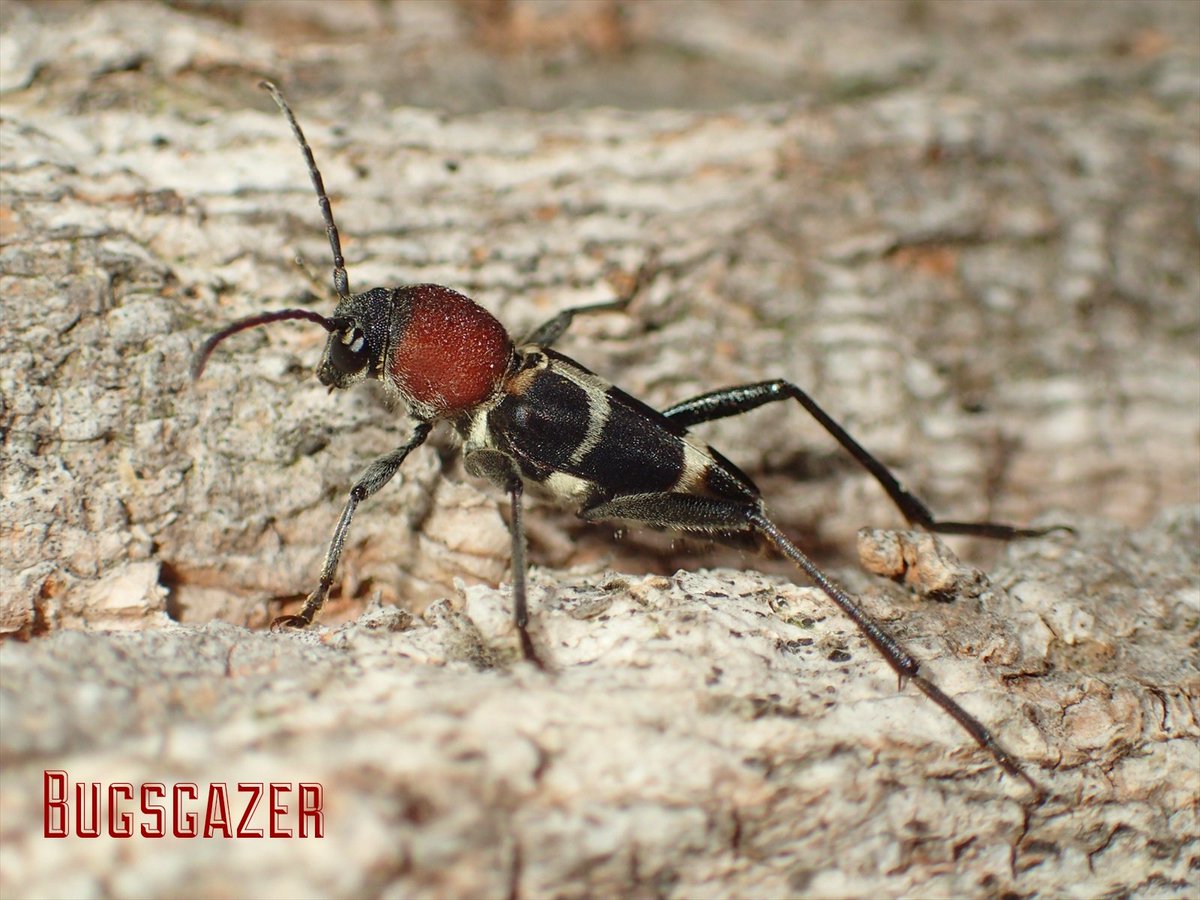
<box><xmin>0</xmin><ymin>510</ymin><xmax>1200</xmax><ymax>896</ymax></box>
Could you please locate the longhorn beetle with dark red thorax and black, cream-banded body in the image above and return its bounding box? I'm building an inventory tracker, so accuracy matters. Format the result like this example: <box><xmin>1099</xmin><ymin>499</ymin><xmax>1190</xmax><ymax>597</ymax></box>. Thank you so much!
<box><xmin>192</xmin><ymin>82</ymin><xmax>1063</xmax><ymax>796</ymax></box>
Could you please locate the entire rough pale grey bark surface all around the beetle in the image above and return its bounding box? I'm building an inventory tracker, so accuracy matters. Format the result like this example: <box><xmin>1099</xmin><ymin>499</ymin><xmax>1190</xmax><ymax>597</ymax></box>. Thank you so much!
<box><xmin>0</xmin><ymin>2</ymin><xmax>1200</xmax><ymax>896</ymax></box>
